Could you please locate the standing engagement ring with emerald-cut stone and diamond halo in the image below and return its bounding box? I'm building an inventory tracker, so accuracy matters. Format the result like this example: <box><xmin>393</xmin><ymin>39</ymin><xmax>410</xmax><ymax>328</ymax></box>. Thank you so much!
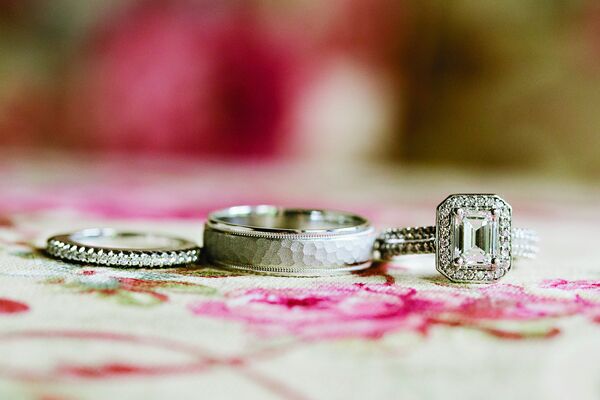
<box><xmin>375</xmin><ymin>194</ymin><xmax>539</xmax><ymax>283</ymax></box>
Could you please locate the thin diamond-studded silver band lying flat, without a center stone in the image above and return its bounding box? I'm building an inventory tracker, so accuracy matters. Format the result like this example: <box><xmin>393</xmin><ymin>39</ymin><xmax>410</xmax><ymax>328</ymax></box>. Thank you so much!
<box><xmin>46</xmin><ymin>228</ymin><xmax>200</xmax><ymax>268</ymax></box>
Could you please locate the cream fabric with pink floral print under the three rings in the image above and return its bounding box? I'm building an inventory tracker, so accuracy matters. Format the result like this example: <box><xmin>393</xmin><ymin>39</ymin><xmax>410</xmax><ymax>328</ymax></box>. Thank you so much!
<box><xmin>0</xmin><ymin>160</ymin><xmax>600</xmax><ymax>400</ymax></box>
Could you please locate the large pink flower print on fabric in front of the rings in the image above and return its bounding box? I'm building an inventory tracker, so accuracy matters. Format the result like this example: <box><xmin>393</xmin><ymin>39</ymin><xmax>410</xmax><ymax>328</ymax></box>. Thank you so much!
<box><xmin>190</xmin><ymin>283</ymin><xmax>600</xmax><ymax>340</ymax></box>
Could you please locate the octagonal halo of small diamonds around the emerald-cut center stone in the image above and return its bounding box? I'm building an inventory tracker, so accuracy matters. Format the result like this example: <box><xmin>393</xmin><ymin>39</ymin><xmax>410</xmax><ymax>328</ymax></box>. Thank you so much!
<box><xmin>436</xmin><ymin>194</ymin><xmax>512</xmax><ymax>283</ymax></box>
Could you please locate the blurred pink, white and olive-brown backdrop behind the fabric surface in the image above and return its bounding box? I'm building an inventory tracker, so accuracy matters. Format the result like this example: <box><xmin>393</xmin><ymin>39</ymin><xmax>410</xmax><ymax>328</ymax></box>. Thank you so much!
<box><xmin>0</xmin><ymin>0</ymin><xmax>600</xmax><ymax>178</ymax></box>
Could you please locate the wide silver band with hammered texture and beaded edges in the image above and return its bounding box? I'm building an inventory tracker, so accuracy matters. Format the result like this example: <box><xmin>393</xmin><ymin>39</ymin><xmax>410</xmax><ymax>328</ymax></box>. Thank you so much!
<box><xmin>204</xmin><ymin>206</ymin><xmax>375</xmax><ymax>276</ymax></box>
